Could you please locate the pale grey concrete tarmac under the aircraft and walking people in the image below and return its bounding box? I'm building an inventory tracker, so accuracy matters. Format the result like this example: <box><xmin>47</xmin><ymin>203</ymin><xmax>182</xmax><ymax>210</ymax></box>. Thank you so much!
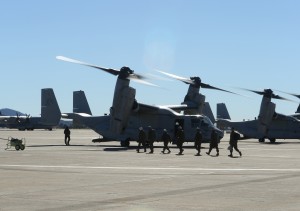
<box><xmin>0</xmin><ymin>129</ymin><xmax>300</xmax><ymax>211</ymax></box>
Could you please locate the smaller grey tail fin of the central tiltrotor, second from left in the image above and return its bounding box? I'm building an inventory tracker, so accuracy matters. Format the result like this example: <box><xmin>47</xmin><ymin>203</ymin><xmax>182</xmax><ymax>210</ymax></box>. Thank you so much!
<box><xmin>73</xmin><ymin>90</ymin><xmax>92</xmax><ymax>115</ymax></box>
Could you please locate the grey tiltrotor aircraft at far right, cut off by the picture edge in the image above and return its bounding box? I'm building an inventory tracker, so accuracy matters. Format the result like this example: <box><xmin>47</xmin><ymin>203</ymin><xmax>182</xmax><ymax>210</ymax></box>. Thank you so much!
<box><xmin>217</xmin><ymin>89</ymin><xmax>300</xmax><ymax>143</ymax></box>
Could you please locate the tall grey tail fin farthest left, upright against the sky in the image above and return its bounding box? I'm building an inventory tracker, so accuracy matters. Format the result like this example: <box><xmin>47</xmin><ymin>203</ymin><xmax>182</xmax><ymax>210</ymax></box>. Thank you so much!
<box><xmin>41</xmin><ymin>88</ymin><xmax>61</xmax><ymax>126</ymax></box>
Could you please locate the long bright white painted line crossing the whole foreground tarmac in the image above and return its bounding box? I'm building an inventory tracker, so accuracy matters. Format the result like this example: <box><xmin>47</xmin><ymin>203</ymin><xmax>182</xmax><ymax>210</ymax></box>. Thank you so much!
<box><xmin>0</xmin><ymin>164</ymin><xmax>300</xmax><ymax>172</ymax></box>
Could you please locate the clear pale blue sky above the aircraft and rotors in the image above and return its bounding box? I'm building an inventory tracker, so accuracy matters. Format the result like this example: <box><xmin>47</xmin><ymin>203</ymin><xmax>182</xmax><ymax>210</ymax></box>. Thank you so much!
<box><xmin>0</xmin><ymin>0</ymin><xmax>300</xmax><ymax>120</ymax></box>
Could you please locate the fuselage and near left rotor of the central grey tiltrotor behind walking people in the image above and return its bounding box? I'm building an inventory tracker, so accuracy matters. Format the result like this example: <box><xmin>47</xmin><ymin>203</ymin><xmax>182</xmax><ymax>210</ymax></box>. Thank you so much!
<box><xmin>56</xmin><ymin>56</ymin><xmax>224</xmax><ymax>146</ymax></box>
